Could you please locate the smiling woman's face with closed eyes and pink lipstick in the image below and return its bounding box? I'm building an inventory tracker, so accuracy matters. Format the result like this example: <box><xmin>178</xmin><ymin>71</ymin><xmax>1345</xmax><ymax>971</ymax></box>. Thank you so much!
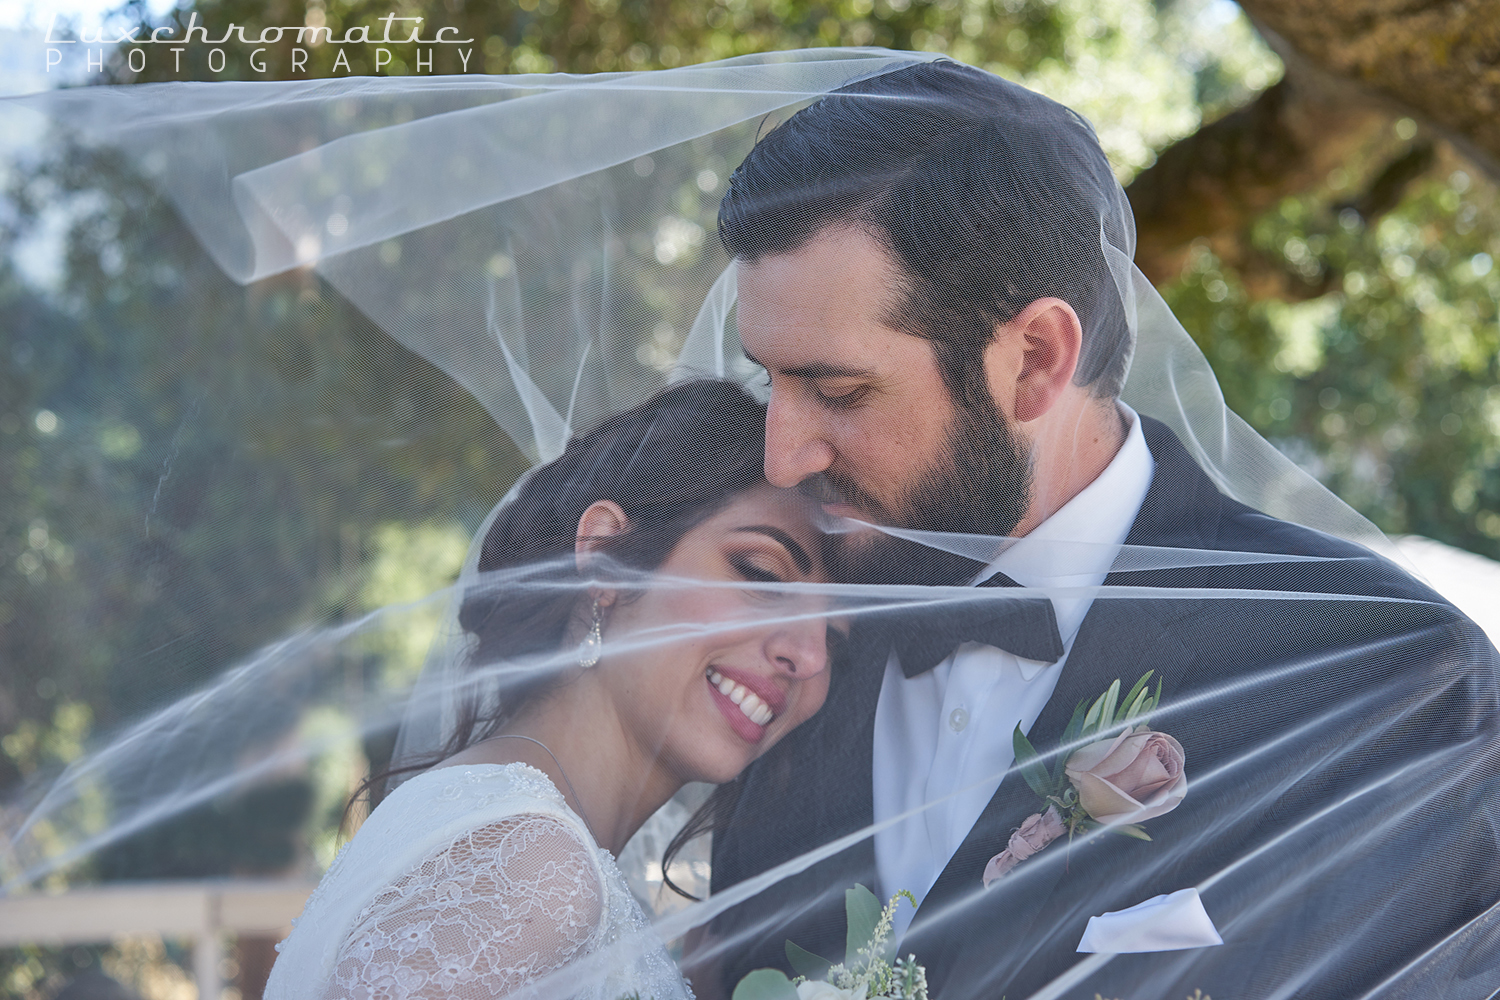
<box><xmin>599</xmin><ymin>486</ymin><xmax>831</xmax><ymax>783</ymax></box>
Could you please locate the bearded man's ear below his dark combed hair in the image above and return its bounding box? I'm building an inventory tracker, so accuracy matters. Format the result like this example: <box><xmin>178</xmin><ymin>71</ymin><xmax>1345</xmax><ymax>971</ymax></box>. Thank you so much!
<box><xmin>984</xmin><ymin>298</ymin><xmax>1083</xmax><ymax>423</ymax></box>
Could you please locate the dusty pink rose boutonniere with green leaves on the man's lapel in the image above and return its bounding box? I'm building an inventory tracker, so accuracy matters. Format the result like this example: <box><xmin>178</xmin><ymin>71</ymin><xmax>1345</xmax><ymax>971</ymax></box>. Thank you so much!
<box><xmin>984</xmin><ymin>670</ymin><xmax>1188</xmax><ymax>888</ymax></box>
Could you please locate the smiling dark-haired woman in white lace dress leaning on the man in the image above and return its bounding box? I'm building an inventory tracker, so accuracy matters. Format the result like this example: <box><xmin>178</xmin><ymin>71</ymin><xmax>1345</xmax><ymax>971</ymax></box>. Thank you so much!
<box><xmin>266</xmin><ymin>381</ymin><xmax>830</xmax><ymax>1000</ymax></box>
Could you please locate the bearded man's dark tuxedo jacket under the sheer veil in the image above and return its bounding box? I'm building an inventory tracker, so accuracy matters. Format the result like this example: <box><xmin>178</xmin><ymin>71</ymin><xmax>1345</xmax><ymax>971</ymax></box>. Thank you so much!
<box><xmin>713</xmin><ymin>418</ymin><xmax>1500</xmax><ymax>1000</ymax></box>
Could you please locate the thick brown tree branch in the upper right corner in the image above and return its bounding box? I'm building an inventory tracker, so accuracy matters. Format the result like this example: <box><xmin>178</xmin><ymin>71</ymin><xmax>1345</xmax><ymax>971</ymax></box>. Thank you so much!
<box><xmin>1128</xmin><ymin>0</ymin><xmax>1500</xmax><ymax>284</ymax></box>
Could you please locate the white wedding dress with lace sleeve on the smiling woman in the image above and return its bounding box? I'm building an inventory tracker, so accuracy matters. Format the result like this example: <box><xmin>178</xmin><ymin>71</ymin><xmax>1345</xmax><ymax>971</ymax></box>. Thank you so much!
<box><xmin>266</xmin><ymin>763</ymin><xmax>692</xmax><ymax>1000</ymax></box>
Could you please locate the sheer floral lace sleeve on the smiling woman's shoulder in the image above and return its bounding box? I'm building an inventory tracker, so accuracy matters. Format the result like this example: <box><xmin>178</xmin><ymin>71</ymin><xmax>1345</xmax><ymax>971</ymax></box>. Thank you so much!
<box><xmin>323</xmin><ymin>814</ymin><xmax>603</xmax><ymax>1000</ymax></box>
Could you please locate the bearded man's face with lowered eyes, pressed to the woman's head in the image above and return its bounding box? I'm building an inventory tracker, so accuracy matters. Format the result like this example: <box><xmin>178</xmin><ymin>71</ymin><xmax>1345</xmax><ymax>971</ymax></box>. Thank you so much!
<box><xmin>738</xmin><ymin>226</ymin><xmax>1029</xmax><ymax>583</ymax></box>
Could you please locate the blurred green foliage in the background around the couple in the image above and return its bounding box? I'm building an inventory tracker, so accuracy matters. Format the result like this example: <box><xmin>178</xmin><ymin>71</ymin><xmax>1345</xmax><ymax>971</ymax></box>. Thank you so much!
<box><xmin>0</xmin><ymin>0</ymin><xmax>1500</xmax><ymax>996</ymax></box>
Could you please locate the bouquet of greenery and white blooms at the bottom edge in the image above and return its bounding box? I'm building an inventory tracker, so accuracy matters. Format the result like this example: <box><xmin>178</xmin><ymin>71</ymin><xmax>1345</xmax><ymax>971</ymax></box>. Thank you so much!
<box><xmin>732</xmin><ymin>886</ymin><xmax>927</xmax><ymax>1000</ymax></box>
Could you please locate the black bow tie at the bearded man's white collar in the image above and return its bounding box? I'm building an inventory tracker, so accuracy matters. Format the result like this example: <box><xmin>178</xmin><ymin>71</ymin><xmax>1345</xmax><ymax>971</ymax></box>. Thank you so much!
<box><xmin>861</xmin><ymin>574</ymin><xmax>1064</xmax><ymax>678</ymax></box>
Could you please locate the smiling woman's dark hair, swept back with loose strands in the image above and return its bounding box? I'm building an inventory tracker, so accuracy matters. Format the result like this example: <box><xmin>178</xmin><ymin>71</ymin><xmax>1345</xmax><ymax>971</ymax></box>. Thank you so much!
<box><xmin>356</xmin><ymin>379</ymin><xmax>765</xmax><ymax>895</ymax></box>
